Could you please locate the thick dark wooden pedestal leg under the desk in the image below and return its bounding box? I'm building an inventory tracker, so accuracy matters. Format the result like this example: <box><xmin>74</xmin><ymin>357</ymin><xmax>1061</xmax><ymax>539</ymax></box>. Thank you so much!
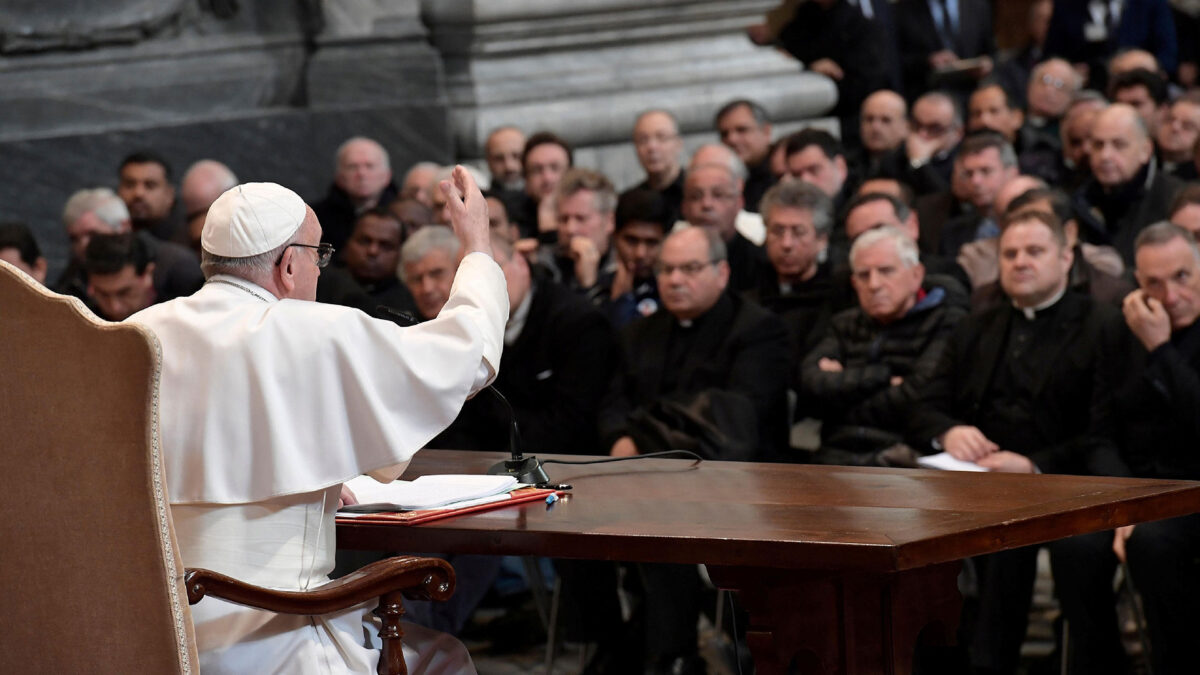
<box><xmin>708</xmin><ymin>562</ymin><xmax>962</xmax><ymax>675</ymax></box>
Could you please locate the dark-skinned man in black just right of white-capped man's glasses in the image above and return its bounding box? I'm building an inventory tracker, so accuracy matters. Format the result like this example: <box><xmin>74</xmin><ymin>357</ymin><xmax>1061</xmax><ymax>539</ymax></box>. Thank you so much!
<box><xmin>317</xmin><ymin>207</ymin><xmax>416</xmax><ymax>315</ymax></box>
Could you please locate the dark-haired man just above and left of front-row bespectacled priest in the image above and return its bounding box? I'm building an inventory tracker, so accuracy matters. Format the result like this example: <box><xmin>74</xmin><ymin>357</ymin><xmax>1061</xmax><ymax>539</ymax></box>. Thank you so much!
<box><xmin>592</xmin><ymin>190</ymin><xmax>674</xmax><ymax>328</ymax></box>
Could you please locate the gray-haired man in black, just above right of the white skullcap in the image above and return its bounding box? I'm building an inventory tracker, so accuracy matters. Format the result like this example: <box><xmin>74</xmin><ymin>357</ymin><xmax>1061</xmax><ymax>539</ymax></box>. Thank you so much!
<box><xmin>312</xmin><ymin>136</ymin><xmax>398</xmax><ymax>250</ymax></box>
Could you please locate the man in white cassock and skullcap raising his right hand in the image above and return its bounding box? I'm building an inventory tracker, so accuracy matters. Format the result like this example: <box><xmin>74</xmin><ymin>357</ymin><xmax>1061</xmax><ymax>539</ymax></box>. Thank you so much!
<box><xmin>127</xmin><ymin>167</ymin><xmax>509</xmax><ymax>674</ymax></box>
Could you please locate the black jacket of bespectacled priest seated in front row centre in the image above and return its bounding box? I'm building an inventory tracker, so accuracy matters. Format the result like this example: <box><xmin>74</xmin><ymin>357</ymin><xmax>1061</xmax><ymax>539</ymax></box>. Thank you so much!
<box><xmin>600</xmin><ymin>292</ymin><xmax>790</xmax><ymax>460</ymax></box>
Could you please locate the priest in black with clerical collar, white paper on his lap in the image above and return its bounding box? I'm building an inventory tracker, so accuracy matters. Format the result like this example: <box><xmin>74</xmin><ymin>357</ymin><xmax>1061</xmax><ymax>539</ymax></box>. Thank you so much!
<box><xmin>910</xmin><ymin>210</ymin><xmax>1120</xmax><ymax>673</ymax></box>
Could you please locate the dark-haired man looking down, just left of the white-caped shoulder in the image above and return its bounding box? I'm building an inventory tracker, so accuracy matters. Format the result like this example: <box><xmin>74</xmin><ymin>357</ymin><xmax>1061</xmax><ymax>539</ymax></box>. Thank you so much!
<box><xmin>83</xmin><ymin>232</ymin><xmax>193</xmax><ymax>321</ymax></box>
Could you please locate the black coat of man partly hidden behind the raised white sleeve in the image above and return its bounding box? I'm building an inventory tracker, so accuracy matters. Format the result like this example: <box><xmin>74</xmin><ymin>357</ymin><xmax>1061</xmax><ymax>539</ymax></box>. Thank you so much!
<box><xmin>428</xmin><ymin>276</ymin><xmax>617</xmax><ymax>454</ymax></box>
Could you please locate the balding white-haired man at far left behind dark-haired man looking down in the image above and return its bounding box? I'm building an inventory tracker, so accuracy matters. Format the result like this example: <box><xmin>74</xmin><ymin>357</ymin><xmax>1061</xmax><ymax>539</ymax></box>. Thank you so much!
<box><xmin>53</xmin><ymin>187</ymin><xmax>204</xmax><ymax>313</ymax></box>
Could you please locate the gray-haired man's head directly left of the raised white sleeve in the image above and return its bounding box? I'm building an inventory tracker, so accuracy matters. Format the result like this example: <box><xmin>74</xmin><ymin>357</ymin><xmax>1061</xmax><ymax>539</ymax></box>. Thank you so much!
<box><xmin>400</xmin><ymin>225</ymin><xmax>461</xmax><ymax>321</ymax></box>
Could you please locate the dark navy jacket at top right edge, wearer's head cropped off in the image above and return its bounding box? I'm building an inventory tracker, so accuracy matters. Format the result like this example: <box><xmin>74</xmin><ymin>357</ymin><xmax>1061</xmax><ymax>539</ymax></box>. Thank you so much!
<box><xmin>1045</xmin><ymin>0</ymin><xmax>1178</xmax><ymax>72</ymax></box>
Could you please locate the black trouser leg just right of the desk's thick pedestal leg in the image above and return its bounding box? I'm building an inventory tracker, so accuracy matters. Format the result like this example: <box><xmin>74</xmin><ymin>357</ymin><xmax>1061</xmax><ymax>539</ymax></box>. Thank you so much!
<box><xmin>970</xmin><ymin>546</ymin><xmax>1038</xmax><ymax>674</ymax></box>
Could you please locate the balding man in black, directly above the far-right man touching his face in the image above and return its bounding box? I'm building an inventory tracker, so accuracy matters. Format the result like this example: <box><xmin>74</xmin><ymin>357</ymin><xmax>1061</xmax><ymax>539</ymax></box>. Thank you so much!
<box><xmin>1074</xmin><ymin>103</ymin><xmax>1182</xmax><ymax>267</ymax></box>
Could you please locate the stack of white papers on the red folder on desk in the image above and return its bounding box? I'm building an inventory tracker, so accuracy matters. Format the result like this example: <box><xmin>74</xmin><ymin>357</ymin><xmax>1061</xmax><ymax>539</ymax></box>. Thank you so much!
<box><xmin>346</xmin><ymin>474</ymin><xmax>517</xmax><ymax>510</ymax></box>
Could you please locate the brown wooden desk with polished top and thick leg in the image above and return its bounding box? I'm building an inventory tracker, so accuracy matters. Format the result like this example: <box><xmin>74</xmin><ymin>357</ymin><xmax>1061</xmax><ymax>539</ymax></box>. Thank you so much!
<box><xmin>337</xmin><ymin>450</ymin><xmax>1200</xmax><ymax>675</ymax></box>
